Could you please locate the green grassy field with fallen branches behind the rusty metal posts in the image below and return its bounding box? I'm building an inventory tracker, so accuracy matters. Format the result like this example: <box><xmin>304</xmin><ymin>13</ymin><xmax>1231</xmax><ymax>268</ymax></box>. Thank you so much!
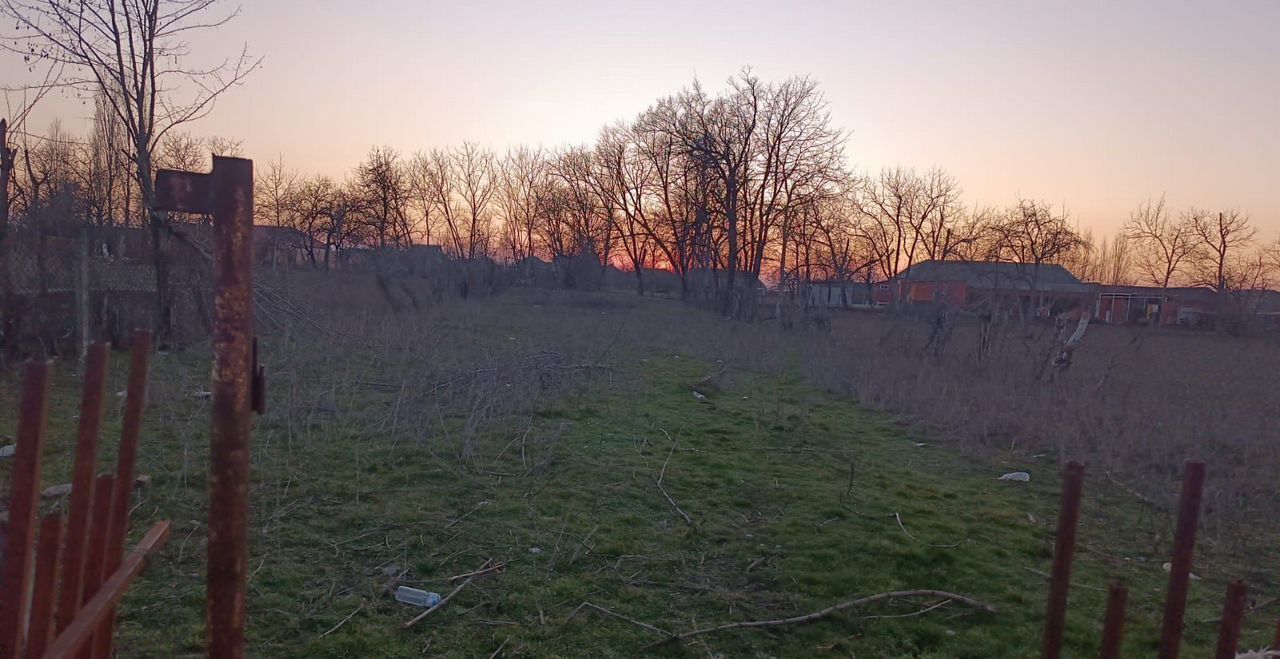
<box><xmin>0</xmin><ymin>292</ymin><xmax>1280</xmax><ymax>658</ymax></box>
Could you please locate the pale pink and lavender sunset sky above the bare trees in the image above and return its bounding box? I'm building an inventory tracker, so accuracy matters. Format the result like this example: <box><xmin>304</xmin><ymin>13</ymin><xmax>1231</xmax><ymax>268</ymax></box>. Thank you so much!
<box><xmin>0</xmin><ymin>0</ymin><xmax>1280</xmax><ymax>235</ymax></box>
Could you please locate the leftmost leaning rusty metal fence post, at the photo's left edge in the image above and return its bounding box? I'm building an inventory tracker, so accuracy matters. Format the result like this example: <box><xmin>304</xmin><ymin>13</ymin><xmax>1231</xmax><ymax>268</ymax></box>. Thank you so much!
<box><xmin>0</xmin><ymin>361</ymin><xmax>50</xmax><ymax>658</ymax></box>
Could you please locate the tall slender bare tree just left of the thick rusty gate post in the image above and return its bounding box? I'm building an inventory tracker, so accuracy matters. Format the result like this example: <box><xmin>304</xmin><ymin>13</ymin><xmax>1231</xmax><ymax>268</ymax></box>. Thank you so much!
<box><xmin>0</xmin><ymin>0</ymin><xmax>261</xmax><ymax>329</ymax></box>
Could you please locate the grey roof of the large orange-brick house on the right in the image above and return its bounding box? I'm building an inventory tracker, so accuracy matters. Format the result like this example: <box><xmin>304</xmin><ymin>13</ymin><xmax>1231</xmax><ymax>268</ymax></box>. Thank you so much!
<box><xmin>899</xmin><ymin>261</ymin><xmax>1093</xmax><ymax>293</ymax></box>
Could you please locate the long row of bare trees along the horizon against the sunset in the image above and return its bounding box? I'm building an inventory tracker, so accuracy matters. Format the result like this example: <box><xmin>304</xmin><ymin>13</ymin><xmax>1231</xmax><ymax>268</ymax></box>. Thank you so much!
<box><xmin>5</xmin><ymin>48</ymin><xmax>1280</xmax><ymax>319</ymax></box>
